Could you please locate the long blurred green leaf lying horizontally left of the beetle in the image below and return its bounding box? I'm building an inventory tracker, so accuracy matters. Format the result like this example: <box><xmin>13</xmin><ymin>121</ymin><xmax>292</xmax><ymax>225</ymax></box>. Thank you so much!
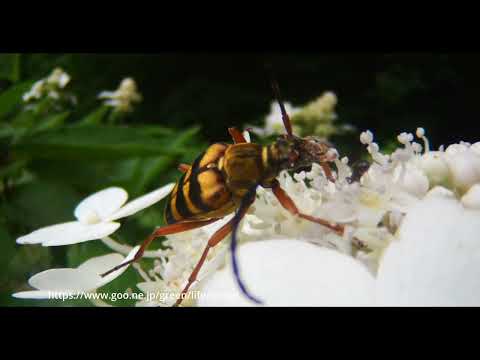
<box><xmin>12</xmin><ymin>126</ymin><xmax>198</xmax><ymax>160</ymax></box>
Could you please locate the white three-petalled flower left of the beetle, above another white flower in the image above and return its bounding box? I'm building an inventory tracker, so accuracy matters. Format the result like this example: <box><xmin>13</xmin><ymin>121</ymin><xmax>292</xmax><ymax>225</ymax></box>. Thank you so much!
<box><xmin>17</xmin><ymin>184</ymin><xmax>174</xmax><ymax>246</ymax></box>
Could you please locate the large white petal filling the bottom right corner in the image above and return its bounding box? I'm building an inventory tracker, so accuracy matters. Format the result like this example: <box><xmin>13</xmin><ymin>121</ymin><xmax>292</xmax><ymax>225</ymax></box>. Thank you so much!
<box><xmin>377</xmin><ymin>196</ymin><xmax>480</xmax><ymax>306</ymax></box>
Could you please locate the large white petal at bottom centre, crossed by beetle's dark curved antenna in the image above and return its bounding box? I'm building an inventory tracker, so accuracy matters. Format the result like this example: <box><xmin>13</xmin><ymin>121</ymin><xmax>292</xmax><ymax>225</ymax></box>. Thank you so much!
<box><xmin>199</xmin><ymin>240</ymin><xmax>374</xmax><ymax>306</ymax></box>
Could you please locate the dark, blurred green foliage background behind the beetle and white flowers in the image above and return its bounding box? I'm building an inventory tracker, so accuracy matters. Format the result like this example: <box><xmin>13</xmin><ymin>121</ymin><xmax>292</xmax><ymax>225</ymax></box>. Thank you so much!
<box><xmin>0</xmin><ymin>53</ymin><xmax>480</xmax><ymax>306</ymax></box>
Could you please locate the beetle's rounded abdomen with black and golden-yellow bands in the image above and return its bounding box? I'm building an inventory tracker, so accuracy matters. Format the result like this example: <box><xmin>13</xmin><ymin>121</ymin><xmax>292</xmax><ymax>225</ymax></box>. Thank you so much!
<box><xmin>165</xmin><ymin>143</ymin><xmax>235</xmax><ymax>224</ymax></box>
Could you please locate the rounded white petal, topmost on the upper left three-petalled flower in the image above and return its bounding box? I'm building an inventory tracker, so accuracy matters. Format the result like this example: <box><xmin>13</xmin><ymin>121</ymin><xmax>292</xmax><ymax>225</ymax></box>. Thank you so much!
<box><xmin>74</xmin><ymin>187</ymin><xmax>128</xmax><ymax>223</ymax></box>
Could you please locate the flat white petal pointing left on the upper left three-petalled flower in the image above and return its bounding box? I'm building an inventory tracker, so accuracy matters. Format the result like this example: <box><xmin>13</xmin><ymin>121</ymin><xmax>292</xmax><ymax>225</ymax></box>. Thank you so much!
<box><xmin>17</xmin><ymin>221</ymin><xmax>120</xmax><ymax>246</ymax></box>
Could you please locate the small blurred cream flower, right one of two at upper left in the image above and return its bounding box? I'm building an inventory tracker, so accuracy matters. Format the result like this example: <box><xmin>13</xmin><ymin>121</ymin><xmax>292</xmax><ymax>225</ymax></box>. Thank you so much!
<box><xmin>98</xmin><ymin>78</ymin><xmax>142</xmax><ymax>112</ymax></box>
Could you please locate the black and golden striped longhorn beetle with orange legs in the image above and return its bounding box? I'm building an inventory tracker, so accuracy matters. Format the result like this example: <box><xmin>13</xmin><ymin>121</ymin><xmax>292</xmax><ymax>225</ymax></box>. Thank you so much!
<box><xmin>102</xmin><ymin>81</ymin><xmax>344</xmax><ymax>306</ymax></box>
